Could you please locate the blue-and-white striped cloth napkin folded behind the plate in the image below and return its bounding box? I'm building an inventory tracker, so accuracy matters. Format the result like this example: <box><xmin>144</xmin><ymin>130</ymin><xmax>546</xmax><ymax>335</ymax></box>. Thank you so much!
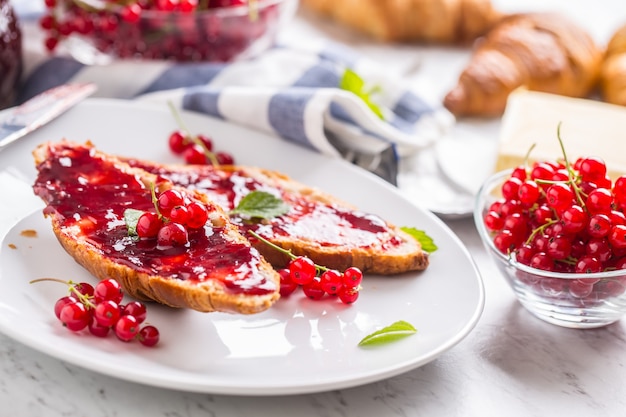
<box><xmin>19</xmin><ymin>36</ymin><xmax>454</xmax><ymax>184</ymax></box>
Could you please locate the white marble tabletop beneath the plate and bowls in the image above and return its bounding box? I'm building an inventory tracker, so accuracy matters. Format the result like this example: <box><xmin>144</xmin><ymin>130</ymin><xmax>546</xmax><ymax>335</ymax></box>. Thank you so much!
<box><xmin>0</xmin><ymin>0</ymin><xmax>626</xmax><ymax>417</ymax></box>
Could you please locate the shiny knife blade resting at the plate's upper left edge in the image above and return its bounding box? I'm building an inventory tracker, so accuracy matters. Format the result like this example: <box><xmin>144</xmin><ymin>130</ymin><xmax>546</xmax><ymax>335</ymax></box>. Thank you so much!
<box><xmin>0</xmin><ymin>83</ymin><xmax>98</xmax><ymax>151</ymax></box>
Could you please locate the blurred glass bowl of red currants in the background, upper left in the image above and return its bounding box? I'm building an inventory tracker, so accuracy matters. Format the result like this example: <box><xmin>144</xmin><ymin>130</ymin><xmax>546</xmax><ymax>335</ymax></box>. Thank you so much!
<box><xmin>40</xmin><ymin>0</ymin><xmax>298</xmax><ymax>65</ymax></box>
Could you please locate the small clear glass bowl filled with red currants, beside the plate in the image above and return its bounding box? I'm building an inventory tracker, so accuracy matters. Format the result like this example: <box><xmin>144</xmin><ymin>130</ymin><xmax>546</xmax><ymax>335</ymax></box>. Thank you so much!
<box><xmin>474</xmin><ymin>158</ymin><xmax>626</xmax><ymax>329</ymax></box>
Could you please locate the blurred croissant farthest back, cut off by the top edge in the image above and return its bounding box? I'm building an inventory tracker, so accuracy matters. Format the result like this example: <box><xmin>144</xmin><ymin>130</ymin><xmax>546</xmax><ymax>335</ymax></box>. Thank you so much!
<box><xmin>301</xmin><ymin>0</ymin><xmax>501</xmax><ymax>43</ymax></box>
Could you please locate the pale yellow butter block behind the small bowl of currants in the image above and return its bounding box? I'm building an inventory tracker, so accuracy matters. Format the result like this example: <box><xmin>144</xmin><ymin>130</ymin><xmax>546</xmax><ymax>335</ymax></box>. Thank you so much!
<box><xmin>495</xmin><ymin>89</ymin><xmax>626</xmax><ymax>178</ymax></box>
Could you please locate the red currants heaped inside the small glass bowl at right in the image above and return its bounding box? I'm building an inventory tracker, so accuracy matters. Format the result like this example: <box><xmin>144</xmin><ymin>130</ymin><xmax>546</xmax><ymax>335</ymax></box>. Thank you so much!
<box><xmin>484</xmin><ymin>157</ymin><xmax>626</xmax><ymax>273</ymax></box>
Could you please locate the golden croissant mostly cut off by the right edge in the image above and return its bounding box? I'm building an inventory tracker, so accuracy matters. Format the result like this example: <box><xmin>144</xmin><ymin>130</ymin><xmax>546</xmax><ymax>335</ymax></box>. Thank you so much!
<box><xmin>600</xmin><ymin>25</ymin><xmax>626</xmax><ymax>106</ymax></box>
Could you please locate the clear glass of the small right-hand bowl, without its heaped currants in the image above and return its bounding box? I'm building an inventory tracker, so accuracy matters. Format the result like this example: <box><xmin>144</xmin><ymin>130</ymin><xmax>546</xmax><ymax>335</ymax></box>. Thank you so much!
<box><xmin>474</xmin><ymin>170</ymin><xmax>626</xmax><ymax>329</ymax></box>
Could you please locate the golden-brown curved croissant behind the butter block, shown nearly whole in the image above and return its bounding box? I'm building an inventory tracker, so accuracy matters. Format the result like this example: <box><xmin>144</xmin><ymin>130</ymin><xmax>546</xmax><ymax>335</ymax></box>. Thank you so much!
<box><xmin>444</xmin><ymin>13</ymin><xmax>602</xmax><ymax>117</ymax></box>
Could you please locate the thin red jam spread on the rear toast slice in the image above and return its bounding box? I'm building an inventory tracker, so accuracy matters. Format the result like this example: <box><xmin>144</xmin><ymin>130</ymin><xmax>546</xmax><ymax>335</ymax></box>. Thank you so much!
<box><xmin>130</xmin><ymin>160</ymin><xmax>402</xmax><ymax>249</ymax></box>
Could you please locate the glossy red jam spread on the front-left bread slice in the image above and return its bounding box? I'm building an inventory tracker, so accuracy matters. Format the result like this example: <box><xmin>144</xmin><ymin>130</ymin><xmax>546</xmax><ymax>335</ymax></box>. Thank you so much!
<box><xmin>33</xmin><ymin>144</ymin><xmax>275</xmax><ymax>294</ymax></box>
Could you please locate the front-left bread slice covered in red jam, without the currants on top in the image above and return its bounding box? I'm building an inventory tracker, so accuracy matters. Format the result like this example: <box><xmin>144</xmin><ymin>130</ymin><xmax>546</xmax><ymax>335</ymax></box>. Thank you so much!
<box><xmin>33</xmin><ymin>141</ymin><xmax>280</xmax><ymax>314</ymax></box>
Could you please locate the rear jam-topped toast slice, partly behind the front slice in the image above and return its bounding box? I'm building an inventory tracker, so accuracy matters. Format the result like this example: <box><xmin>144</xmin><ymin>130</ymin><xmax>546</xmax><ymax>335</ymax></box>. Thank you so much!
<box><xmin>126</xmin><ymin>159</ymin><xmax>429</xmax><ymax>275</ymax></box>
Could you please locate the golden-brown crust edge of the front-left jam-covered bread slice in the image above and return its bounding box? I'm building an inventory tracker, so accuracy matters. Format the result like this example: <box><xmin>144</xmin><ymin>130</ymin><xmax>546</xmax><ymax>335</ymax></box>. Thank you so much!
<box><xmin>33</xmin><ymin>142</ymin><xmax>280</xmax><ymax>314</ymax></box>
